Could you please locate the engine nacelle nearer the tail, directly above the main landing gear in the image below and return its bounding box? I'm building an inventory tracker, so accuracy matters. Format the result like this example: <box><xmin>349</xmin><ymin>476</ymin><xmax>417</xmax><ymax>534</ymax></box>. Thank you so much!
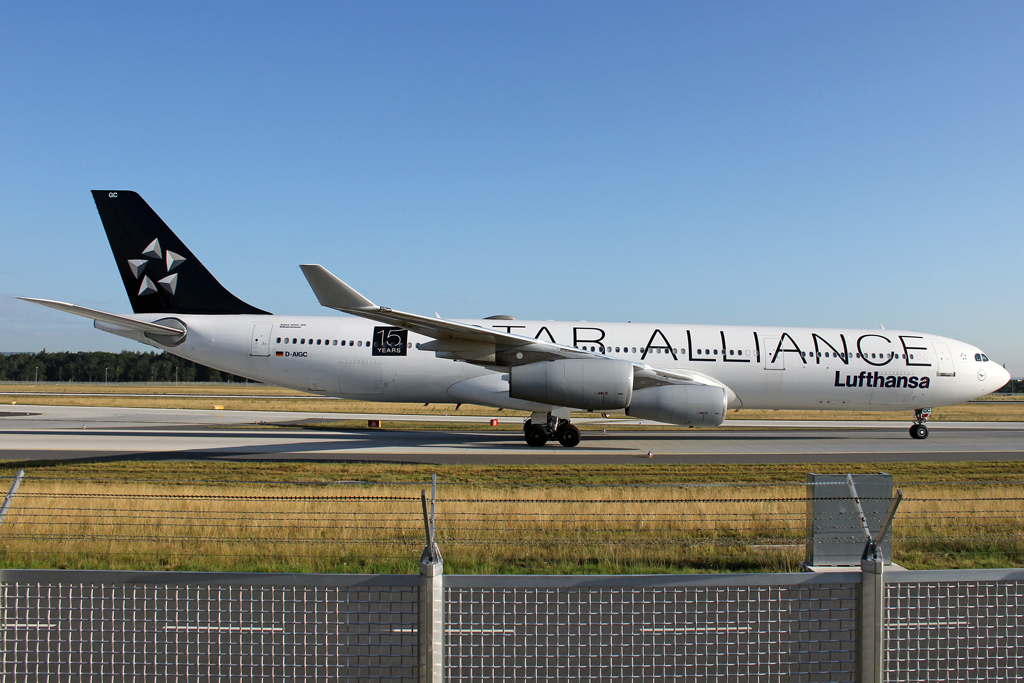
<box><xmin>509</xmin><ymin>358</ymin><xmax>633</xmax><ymax>411</ymax></box>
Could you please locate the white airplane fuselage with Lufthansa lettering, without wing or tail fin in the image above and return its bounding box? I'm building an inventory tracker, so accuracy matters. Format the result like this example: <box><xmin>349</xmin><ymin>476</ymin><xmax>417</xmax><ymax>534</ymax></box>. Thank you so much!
<box><xmin>105</xmin><ymin>314</ymin><xmax>1009</xmax><ymax>411</ymax></box>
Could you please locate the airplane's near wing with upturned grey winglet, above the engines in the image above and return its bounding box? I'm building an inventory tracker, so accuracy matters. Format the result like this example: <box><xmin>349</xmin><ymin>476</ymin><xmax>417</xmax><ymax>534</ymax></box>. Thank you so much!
<box><xmin>299</xmin><ymin>264</ymin><xmax>731</xmax><ymax>393</ymax></box>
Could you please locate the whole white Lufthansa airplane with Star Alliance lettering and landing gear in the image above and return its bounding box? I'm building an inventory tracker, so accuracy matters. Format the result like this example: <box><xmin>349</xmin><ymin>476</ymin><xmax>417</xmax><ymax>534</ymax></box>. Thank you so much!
<box><xmin>17</xmin><ymin>190</ymin><xmax>1010</xmax><ymax>447</ymax></box>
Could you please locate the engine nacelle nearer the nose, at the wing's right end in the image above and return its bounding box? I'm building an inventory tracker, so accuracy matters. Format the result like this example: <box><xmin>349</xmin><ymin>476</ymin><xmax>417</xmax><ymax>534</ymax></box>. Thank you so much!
<box><xmin>626</xmin><ymin>384</ymin><xmax>729</xmax><ymax>427</ymax></box>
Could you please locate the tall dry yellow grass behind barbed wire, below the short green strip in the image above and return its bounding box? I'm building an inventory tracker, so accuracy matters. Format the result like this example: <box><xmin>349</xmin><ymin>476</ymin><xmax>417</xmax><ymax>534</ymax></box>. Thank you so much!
<box><xmin>0</xmin><ymin>477</ymin><xmax>1024</xmax><ymax>573</ymax></box>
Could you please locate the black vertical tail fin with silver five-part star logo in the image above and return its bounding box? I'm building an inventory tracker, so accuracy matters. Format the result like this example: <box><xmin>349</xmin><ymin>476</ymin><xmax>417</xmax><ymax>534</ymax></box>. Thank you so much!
<box><xmin>92</xmin><ymin>189</ymin><xmax>268</xmax><ymax>315</ymax></box>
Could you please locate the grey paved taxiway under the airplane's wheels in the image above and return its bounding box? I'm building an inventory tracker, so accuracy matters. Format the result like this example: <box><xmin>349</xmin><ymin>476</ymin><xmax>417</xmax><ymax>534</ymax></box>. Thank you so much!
<box><xmin>0</xmin><ymin>404</ymin><xmax>1024</xmax><ymax>465</ymax></box>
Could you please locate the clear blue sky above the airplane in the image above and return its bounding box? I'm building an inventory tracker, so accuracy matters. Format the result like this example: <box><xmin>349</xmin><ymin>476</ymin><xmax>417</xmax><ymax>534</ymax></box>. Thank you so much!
<box><xmin>0</xmin><ymin>2</ymin><xmax>1024</xmax><ymax>376</ymax></box>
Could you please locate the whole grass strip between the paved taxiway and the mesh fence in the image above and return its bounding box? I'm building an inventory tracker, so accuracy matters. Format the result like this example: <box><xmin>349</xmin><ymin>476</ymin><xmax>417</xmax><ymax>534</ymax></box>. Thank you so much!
<box><xmin>0</xmin><ymin>461</ymin><xmax>1024</xmax><ymax>573</ymax></box>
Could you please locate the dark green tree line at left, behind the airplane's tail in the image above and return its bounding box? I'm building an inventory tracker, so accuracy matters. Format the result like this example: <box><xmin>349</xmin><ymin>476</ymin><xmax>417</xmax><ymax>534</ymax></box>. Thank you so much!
<box><xmin>0</xmin><ymin>349</ymin><xmax>253</xmax><ymax>382</ymax></box>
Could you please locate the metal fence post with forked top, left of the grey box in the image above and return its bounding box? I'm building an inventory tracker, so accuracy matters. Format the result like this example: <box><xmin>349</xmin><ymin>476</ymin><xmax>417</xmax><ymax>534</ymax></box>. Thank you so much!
<box><xmin>419</xmin><ymin>474</ymin><xmax>444</xmax><ymax>683</ymax></box>
